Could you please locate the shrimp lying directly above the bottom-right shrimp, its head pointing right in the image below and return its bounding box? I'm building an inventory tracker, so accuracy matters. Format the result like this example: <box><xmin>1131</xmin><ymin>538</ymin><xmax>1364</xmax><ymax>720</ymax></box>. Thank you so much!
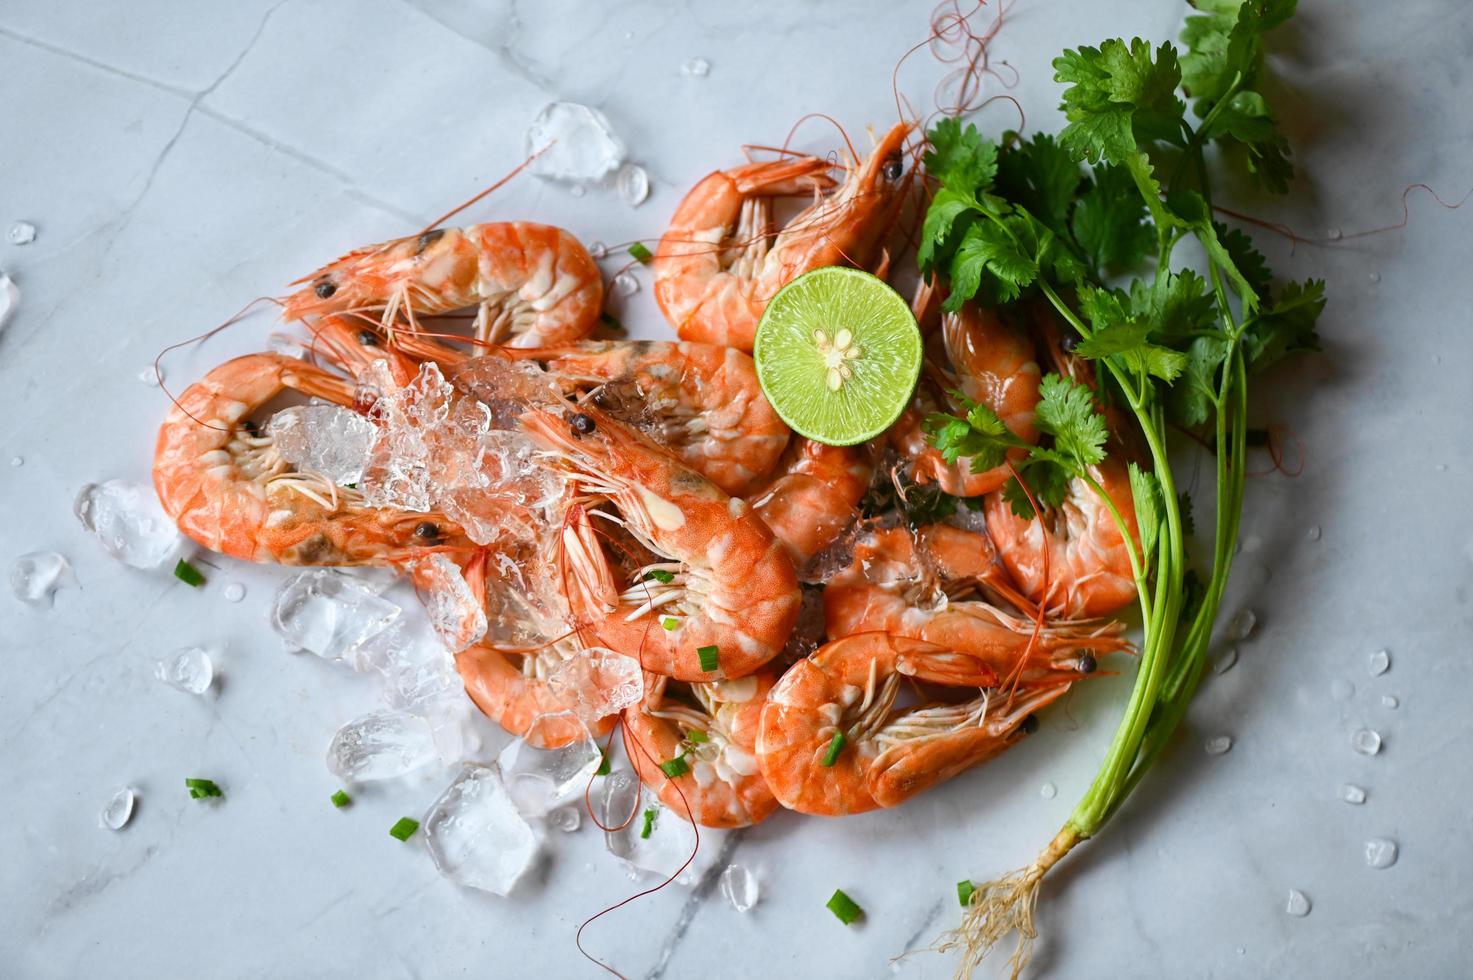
<box><xmin>823</xmin><ymin>525</ymin><xmax>1127</xmax><ymax>687</ymax></box>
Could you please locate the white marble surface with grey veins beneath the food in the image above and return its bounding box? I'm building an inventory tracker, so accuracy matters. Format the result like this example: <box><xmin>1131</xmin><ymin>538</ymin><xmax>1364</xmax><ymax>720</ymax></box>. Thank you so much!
<box><xmin>0</xmin><ymin>0</ymin><xmax>1473</xmax><ymax>980</ymax></box>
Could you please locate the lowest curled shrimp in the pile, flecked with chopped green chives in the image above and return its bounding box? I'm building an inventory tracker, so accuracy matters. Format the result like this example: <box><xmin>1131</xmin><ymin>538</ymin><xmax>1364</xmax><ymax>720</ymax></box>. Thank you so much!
<box><xmin>625</xmin><ymin>671</ymin><xmax>778</xmax><ymax>827</ymax></box>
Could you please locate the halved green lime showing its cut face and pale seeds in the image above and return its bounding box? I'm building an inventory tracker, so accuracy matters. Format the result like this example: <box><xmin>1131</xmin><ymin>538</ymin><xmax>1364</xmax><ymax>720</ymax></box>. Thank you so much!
<box><xmin>751</xmin><ymin>265</ymin><xmax>921</xmax><ymax>445</ymax></box>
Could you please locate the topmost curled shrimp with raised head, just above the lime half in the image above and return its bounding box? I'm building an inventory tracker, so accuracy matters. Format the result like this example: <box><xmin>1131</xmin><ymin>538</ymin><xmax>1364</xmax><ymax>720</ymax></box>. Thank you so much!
<box><xmin>654</xmin><ymin>122</ymin><xmax>912</xmax><ymax>351</ymax></box>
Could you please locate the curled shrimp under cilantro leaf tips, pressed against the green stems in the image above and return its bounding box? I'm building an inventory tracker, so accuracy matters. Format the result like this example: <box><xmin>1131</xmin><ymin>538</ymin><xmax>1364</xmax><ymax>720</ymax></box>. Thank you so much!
<box><xmin>985</xmin><ymin>455</ymin><xmax>1140</xmax><ymax>616</ymax></box>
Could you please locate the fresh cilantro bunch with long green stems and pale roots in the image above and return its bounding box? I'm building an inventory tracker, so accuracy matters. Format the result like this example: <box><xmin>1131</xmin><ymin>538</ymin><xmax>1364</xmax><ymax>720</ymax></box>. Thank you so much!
<box><xmin>919</xmin><ymin>0</ymin><xmax>1324</xmax><ymax>955</ymax></box>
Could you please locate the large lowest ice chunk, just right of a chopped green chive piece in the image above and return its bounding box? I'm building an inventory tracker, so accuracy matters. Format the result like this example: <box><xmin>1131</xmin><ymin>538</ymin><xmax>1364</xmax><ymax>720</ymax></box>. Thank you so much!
<box><xmin>423</xmin><ymin>763</ymin><xmax>538</xmax><ymax>895</ymax></box>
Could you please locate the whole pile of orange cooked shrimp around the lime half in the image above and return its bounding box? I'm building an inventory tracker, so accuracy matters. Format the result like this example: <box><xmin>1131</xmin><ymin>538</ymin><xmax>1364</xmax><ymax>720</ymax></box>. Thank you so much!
<box><xmin>153</xmin><ymin>116</ymin><xmax>1134</xmax><ymax>828</ymax></box>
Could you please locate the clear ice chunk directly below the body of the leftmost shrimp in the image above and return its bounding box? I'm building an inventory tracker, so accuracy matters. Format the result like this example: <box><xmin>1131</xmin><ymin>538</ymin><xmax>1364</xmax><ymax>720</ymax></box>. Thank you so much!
<box><xmin>271</xmin><ymin>569</ymin><xmax>401</xmax><ymax>660</ymax></box>
